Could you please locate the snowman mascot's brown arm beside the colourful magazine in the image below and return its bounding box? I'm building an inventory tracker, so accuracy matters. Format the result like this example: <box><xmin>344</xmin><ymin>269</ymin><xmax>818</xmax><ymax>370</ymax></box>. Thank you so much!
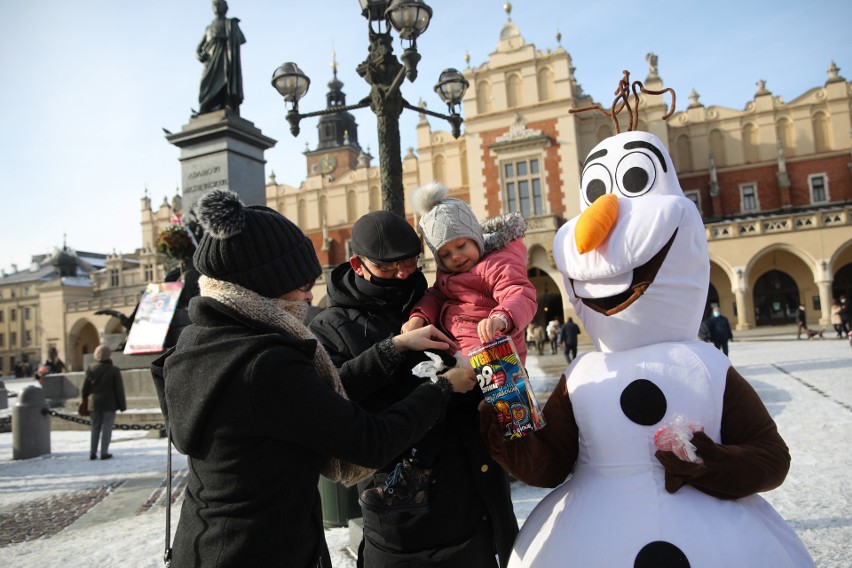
<box><xmin>479</xmin><ymin>375</ymin><xmax>580</xmax><ymax>487</ymax></box>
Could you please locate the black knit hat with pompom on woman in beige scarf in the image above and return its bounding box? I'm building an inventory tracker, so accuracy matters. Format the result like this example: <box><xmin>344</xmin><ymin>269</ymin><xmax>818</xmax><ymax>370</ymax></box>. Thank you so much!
<box><xmin>192</xmin><ymin>189</ymin><xmax>322</xmax><ymax>298</ymax></box>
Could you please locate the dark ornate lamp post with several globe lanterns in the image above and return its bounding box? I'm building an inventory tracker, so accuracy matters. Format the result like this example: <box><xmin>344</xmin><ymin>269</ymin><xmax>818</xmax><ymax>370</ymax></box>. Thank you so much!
<box><xmin>272</xmin><ymin>0</ymin><xmax>469</xmax><ymax>216</ymax></box>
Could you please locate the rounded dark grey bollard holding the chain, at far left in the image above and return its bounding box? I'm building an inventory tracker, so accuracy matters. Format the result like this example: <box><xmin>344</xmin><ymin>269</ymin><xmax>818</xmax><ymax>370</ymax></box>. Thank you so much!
<box><xmin>12</xmin><ymin>386</ymin><xmax>50</xmax><ymax>460</ymax></box>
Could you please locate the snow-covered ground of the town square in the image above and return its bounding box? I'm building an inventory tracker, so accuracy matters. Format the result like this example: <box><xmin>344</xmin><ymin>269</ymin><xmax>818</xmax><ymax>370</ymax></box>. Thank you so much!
<box><xmin>0</xmin><ymin>338</ymin><xmax>852</xmax><ymax>568</ymax></box>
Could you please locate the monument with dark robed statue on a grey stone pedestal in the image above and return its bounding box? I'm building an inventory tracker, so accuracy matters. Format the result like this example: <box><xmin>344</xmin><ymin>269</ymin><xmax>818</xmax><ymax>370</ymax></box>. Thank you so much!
<box><xmin>166</xmin><ymin>0</ymin><xmax>276</xmax><ymax>217</ymax></box>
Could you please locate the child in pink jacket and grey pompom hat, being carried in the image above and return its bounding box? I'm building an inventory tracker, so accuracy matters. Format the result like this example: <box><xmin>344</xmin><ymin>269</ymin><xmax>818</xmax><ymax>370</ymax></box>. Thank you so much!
<box><xmin>361</xmin><ymin>182</ymin><xmax>537</xmax><ymax>512</ymax></box>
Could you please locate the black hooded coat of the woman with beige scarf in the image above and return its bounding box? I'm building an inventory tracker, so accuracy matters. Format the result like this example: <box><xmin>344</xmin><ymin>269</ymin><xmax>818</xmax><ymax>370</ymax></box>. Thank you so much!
<box><xmin>152</xmin><ymin>297</ymin><xmax>447</xmax><ymax>568</ymax></box>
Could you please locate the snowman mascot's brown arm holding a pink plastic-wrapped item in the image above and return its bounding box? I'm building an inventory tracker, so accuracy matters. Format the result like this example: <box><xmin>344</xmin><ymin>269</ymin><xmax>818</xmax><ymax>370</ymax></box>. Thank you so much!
<box><xmin>656</xmin><ymin>367</ymin><xmax>790</xmax><ymax>499</ymax></box>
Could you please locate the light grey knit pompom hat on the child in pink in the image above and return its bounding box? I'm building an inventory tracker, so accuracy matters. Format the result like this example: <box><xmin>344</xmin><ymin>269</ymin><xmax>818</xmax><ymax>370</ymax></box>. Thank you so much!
<box><xmin>411</xmin><ymin>181</ymin><xmax>485</xmax><ymax>268</ymax></box>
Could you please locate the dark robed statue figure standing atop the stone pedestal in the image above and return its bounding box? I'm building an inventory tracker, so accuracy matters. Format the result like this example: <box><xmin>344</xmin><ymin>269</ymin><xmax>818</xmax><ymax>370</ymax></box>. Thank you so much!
<box><xmin>196</xmin><ymin>0</ymin><xmax>246</xmax><ymax>114</ymax></box>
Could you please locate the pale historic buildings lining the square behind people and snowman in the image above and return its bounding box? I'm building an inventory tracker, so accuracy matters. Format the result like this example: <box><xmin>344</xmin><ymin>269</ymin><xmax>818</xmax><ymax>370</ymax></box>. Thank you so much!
<box><xmin>0</xmin><ymin>10</ymin><xmax>852</xmax><ymax>373</ymax></box>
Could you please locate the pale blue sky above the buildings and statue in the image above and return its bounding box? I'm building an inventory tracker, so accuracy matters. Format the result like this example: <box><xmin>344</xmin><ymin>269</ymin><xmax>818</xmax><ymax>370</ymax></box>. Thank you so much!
<box><xmin>0</xmin><ymin>0</ymin><xmax>852</xmax><ymax>272</ymax></box>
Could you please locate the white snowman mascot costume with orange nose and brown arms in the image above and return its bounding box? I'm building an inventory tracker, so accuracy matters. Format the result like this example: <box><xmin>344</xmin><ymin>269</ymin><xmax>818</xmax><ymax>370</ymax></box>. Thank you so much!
<box><xmin>480</xmin><ymin>72</ymin><xmax>813</xmax><ymax>568</ymax></box>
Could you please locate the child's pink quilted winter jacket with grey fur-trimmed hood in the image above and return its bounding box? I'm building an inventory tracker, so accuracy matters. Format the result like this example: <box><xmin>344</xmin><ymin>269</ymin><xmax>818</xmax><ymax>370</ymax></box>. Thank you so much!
<box><xmin>409</xmin><ymin>213</ymin><xmax>538</xmax><ymax>361</ymax></box>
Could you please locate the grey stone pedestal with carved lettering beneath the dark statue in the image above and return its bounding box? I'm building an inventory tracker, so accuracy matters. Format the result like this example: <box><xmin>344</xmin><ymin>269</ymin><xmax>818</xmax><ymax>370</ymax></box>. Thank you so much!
<box><xmin>166</xmin><ymin>110</ymin><xmax>277</xmax><ymax>212</ymax></box>
